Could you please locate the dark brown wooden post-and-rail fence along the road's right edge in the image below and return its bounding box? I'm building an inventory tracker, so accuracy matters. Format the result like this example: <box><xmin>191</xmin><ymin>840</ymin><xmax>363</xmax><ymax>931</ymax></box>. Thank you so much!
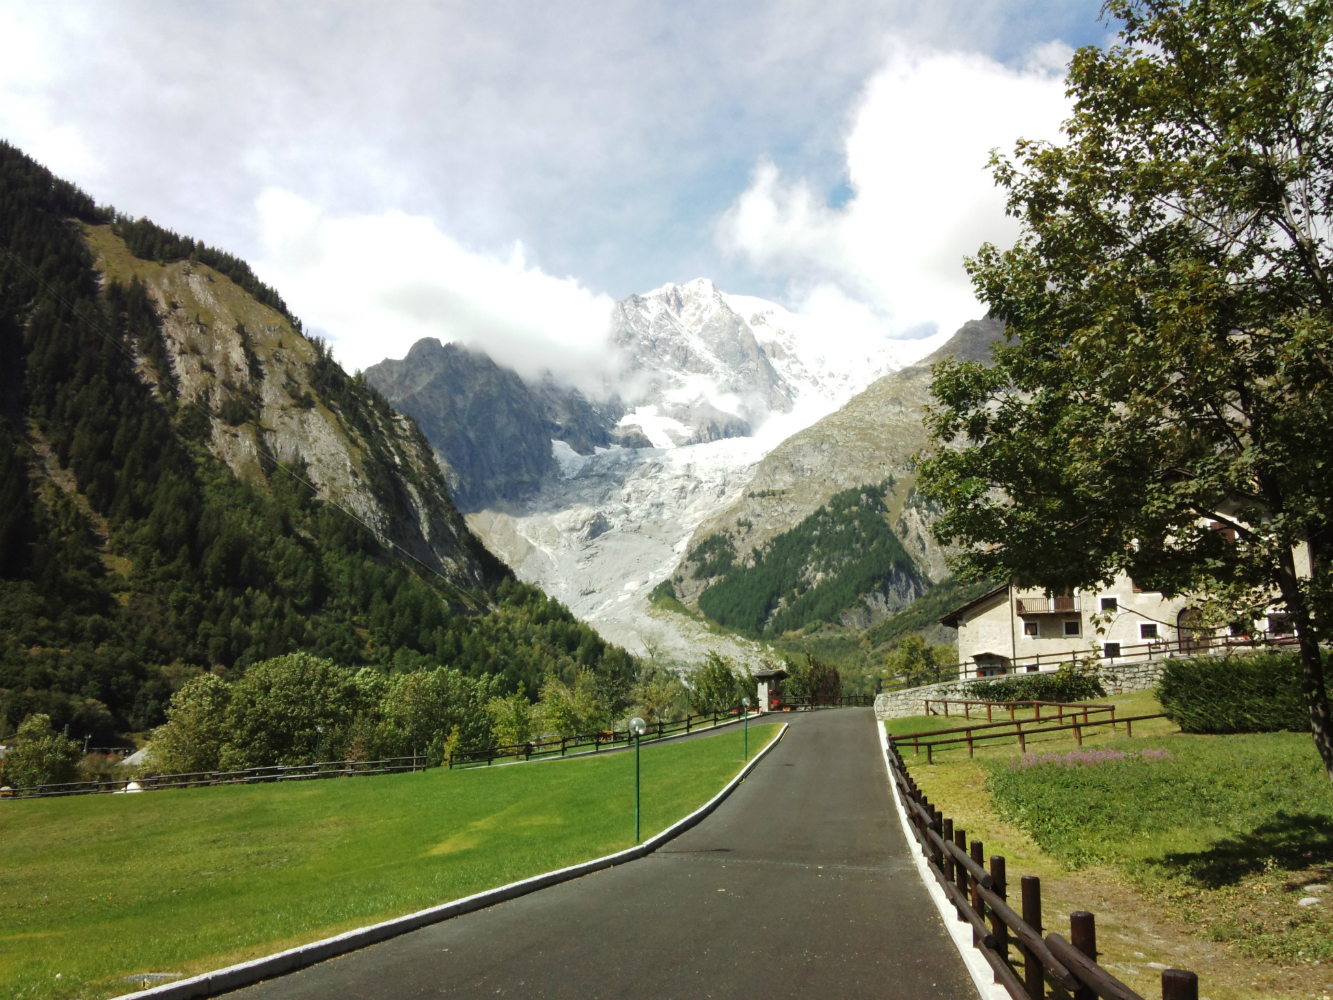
<box><xmin>889</xmin><ymin>743</ymin><xmax>1198</xmax><ymax>1000</ymax></box>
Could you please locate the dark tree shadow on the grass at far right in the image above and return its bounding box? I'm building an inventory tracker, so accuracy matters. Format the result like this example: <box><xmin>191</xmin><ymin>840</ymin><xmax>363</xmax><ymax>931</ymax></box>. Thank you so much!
<box><xmin>1149</xmin><ymin>812</ymin><xmax>1333</xmax><ymax>889</ymax></box>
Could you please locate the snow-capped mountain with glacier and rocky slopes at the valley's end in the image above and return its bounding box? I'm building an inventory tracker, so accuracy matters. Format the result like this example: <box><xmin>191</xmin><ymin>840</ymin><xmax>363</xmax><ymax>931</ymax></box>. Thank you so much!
<box><xmin>367</xmin><ymin>280</ymin><xmax>1002</xmax><ymax>663</ymax></box>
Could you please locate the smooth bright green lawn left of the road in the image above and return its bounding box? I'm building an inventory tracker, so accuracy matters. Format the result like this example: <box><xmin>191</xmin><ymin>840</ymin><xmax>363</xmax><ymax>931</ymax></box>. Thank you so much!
<box><xmin>0</xmin><ymin>724</ymin><xmax>778</xmax><ymax>999</ymax></box>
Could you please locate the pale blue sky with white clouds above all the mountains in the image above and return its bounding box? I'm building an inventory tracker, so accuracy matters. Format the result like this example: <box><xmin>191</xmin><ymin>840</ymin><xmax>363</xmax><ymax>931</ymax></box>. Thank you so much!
<box><xmin>0</xmin><ymin>0</ymin><xmax>1106</xmax><ymax>376</ymax></box>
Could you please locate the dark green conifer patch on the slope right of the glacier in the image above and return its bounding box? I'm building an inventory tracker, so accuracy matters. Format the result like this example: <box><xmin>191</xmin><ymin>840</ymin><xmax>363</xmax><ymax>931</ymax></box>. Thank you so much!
<box><xmin>685</xmin><ymin>483</ymin><xmax>930</xmax><ymax>636</ymax></box>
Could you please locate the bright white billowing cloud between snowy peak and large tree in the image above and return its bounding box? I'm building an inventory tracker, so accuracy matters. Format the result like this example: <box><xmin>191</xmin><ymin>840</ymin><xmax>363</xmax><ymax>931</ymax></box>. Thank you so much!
<box><xmin>717</xmin><ymin>41</ymin><xmax>1069</xmax><ymax>336</ymax></box>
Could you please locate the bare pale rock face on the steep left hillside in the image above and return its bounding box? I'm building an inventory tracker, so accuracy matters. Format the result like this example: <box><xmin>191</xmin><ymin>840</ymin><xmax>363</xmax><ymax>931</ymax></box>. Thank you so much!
<box><xmin>84</xmin><ymin>225</ymin><xmax>493</xmax><ymax>603</ymax></box>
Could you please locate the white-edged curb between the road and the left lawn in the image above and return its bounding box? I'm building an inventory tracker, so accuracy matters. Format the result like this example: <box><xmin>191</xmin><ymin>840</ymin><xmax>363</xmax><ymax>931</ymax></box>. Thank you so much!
<box><xmin>115</xmin><ymin>723</ymin><xmax>790</xmax><ymax>1000</ymax></box>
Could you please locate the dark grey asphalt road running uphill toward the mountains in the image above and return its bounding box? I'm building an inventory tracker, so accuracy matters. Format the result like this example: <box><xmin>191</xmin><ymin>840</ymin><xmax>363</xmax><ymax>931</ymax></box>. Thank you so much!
<box><xmin>231</xmin><ymin>708</ymin><xmax>977</xmax><ymax>1000</ymax></box>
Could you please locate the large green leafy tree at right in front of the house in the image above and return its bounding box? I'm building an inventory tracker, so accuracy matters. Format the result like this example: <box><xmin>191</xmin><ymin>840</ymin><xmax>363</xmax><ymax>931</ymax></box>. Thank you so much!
<box><xmin>922</xmin><ymin>0</ymin><xmax>1333</xmax><ymax>779</ymax></box>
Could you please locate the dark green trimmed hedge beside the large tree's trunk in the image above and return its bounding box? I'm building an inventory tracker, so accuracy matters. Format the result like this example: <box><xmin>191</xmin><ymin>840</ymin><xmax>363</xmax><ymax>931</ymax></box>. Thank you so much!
<box><xmin>1157</xmin><ymin>652</ymin><xmax>1311</xmax><ymax>733</ymax></box>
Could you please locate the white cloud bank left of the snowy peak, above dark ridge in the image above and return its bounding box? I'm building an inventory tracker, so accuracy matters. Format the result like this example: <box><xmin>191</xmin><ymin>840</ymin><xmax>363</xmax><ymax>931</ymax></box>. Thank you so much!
<box><xmin>256</xmin><ymin>188</ymin><xmax>613</xmax><ymax>388</ymax></box>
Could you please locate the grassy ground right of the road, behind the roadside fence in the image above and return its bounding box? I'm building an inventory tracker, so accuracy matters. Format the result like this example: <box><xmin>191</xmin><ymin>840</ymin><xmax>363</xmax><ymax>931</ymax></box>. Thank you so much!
<box><xmin>889</xmin><ymin>693</ymin><xmax>1333</xmax><ymax>1000</ymax></box>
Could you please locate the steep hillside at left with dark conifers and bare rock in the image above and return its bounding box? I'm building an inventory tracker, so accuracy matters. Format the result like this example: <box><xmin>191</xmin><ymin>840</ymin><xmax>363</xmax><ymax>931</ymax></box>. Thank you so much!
<box><xmin>0</xmin><ymin>143</ymin><xmax>633</xmax><ymax>743</ymax></box>
